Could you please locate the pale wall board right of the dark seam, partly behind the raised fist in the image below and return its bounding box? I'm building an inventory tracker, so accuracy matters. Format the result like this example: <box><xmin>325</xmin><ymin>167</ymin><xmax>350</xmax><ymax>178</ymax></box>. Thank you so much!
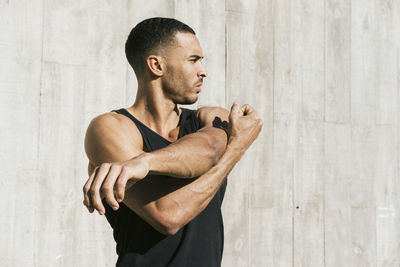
<box><xmin>223</xmin><ymin>8</ymin><xmax>254</xmax><ymax>266</ymax></box>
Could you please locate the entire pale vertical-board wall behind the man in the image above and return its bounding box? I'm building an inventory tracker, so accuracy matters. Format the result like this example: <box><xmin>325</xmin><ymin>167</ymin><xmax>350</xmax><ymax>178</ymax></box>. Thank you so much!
<box><xmin>0</xmin><ymin>0</ymin><xmax>400</xmax><ymax>267</ymax></box>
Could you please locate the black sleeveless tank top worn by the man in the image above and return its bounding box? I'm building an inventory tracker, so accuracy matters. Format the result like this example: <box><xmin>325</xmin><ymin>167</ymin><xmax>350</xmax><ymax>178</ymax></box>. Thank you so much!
<box><xmin>103</xmin><ymin>108</ymin><xmax>226</xmax><ymax>267</ymax></box>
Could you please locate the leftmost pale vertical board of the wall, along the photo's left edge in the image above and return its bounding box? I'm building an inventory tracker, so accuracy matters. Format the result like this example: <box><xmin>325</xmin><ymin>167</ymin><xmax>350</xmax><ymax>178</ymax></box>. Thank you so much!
<box><xmin>0</xmin><ymin>0</ymin><xmax>42</xmax><ymax>266</ymax></box>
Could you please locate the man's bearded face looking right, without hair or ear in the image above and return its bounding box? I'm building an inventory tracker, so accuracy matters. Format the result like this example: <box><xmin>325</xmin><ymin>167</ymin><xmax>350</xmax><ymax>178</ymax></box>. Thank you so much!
<box><xmin>163</xmin><ymin>32</ymin><xmax>207</xmax><ymax>104</ymax></box>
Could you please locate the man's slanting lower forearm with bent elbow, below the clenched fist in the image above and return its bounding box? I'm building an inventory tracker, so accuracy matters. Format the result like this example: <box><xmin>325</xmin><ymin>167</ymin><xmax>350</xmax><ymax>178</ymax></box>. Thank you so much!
<box><xmin>124</xmin><ymin>143</ymin><xmax>244</xmax><ymax>234</ymax></box>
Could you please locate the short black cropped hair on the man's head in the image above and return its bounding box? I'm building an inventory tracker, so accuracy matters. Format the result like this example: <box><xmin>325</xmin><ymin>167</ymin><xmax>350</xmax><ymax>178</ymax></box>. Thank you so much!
<box><xmin>125</xmin><ymin>17</ymin><xmax>196</xmax><ymax>75</ymax></box>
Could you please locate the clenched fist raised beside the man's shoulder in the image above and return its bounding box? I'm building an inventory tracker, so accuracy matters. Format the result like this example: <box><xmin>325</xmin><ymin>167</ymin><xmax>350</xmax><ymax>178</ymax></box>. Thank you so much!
<box><xmin>228</xmin><ymin>102</ymin><xmax>263</xmax><ymax>151</ymax></box>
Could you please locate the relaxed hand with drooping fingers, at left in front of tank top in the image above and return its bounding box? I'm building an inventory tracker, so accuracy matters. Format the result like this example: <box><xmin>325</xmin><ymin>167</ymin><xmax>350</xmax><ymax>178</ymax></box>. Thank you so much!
<box><xmin>83</xmin><ymin>154</ymin><xmax>149</xmax><ymax>215</ymax></box>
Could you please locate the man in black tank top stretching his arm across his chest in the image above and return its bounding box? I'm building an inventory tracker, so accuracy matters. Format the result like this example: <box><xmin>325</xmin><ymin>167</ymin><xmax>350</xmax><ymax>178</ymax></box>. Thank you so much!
<box><xmin>83</xmin><ymin>18</ymin><xmax>262</xmax><ymax>267</ymax></box>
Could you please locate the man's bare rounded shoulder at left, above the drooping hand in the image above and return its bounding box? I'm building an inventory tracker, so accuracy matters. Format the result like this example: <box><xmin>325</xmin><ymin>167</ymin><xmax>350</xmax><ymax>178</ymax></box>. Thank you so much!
<box><xmin>85</xmin><ymin>112</ymin><xmax>143</xmax><ymax>166</ymax></box>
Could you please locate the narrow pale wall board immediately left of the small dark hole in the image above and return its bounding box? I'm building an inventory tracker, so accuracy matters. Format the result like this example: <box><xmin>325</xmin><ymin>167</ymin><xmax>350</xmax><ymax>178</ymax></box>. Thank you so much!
<box><xmin>269</xmin><ymin>0</ymin><xmax>297</xmax><ymax>260</ymax></box>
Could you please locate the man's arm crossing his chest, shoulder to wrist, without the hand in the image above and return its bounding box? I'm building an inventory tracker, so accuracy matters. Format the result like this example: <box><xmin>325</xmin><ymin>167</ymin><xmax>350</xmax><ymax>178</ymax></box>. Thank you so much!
<box><xmin>141</xmin><ymin>107</ymin><xmax>229</xmax><ymax>178</ymax></box>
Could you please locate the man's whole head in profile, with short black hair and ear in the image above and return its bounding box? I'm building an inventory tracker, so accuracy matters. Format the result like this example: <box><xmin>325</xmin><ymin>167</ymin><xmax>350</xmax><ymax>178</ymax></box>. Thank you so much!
<box><xmin>125</xmin><ymin>18</ymin><xmax>207</xmax><ymax>104</ymax></box>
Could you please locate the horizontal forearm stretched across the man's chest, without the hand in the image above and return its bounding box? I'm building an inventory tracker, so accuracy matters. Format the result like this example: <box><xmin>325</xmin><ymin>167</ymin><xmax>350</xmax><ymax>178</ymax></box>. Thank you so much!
<box><xmin>141</xmin><ymin>127</ymin><xmax>227</xmax><ymax>178</ymax></box>
